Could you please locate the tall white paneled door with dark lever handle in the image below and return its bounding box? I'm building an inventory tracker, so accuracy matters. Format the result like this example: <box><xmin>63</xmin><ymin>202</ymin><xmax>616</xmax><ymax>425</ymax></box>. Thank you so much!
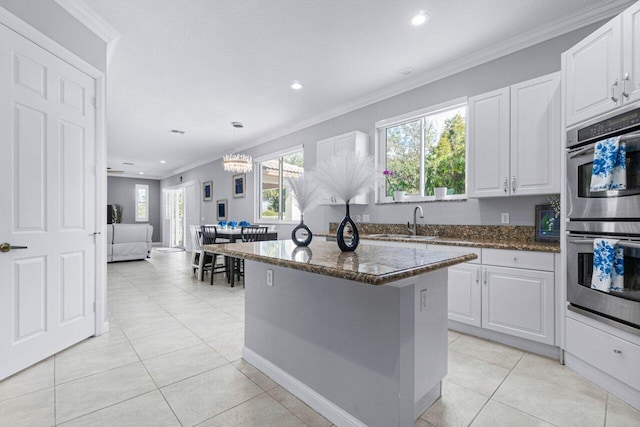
<box><xmin>0</xmin><ymin>25</ymin><xmax>96</xmax><ymax>380</ymax></box>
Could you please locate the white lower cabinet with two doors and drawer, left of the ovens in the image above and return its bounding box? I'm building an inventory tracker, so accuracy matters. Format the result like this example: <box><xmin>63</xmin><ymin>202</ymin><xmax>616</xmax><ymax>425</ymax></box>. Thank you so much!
<box><xmin>442</xmin><ymin>245</ymin><xmax>556</xmax><ymax>345</ymax></box>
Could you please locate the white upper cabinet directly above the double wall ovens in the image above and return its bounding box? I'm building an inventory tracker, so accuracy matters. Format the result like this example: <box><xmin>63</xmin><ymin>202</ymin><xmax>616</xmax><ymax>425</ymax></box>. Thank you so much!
<box><xmin>563</xmin><ymin>3</ymin><xmax>640</xmax><ymax>126</ymax></box>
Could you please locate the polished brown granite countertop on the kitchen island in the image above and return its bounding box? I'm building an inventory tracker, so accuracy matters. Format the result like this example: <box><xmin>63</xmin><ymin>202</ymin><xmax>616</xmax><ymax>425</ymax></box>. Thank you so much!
<box><xmin>203</xmin><ymin>239</ymin><xmax>477</xmax><ymax>285</ymax></box>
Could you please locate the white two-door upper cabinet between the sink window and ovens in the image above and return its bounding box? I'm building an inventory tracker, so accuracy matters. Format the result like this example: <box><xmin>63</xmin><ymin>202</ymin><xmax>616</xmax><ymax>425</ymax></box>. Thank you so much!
<box><xmin>468</xmin><ymin>73</ymin><xmax>561</xmax><ymax>197</ymax></box>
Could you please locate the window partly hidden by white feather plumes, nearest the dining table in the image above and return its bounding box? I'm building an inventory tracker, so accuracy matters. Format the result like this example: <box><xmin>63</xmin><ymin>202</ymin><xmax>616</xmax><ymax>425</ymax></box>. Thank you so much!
<box><xmin>257</xmin><ymin>148</ymin><xmax>304</xmax><ymax>221</ymax></box>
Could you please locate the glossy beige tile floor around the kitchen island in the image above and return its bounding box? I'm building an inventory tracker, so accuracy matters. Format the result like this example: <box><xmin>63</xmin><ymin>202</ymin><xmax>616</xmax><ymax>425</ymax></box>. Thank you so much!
<box><xmin>0</xmin><ymin>251</ymin><xmax>640</xmax><ymax>427</ymax></box>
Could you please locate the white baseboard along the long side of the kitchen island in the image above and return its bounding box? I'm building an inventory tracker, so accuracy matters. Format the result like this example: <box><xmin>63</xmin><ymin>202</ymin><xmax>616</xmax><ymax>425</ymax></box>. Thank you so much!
<box><xmin>242</xmin><ymin>346</ymin><xmax>368</xmax><ymax>427</ymax></box>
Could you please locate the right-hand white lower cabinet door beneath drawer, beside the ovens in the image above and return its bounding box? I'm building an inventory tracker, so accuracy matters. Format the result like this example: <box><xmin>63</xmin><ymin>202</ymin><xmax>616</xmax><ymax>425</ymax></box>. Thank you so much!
<box><xmin>482</xmin><ymin>267</ymin><xmax>555</xmax><ymax>345</ymax></box>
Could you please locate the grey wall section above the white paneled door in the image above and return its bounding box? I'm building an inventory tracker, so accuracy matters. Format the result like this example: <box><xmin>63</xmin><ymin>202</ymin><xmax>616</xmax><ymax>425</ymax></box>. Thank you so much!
<box><xmin>0</xmin><ymin>0</ymin><xmax>107</xmax><ymax>72</ymax></box>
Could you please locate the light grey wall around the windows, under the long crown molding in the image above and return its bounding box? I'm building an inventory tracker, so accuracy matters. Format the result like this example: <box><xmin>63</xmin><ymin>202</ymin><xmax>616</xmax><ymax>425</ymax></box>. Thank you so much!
<box><xmin>161</xmin><ymin>24</ymin><xmax>601</xmax><ymax>237</ymax></box>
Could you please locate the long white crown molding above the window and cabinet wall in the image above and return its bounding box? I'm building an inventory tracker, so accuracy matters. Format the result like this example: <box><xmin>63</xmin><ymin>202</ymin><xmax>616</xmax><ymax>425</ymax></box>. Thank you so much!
<box><xmin>242</xmin><ymin>0</ymin><xmax>635</xmax><ymax>150</ymax></box>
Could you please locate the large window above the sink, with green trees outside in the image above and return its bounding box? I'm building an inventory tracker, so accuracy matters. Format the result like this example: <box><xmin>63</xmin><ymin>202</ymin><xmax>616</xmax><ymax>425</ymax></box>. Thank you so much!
<box><xmin>376</xmin><ymin>99</ymin><xmax>467</xmax><ymax>201</ymax></box>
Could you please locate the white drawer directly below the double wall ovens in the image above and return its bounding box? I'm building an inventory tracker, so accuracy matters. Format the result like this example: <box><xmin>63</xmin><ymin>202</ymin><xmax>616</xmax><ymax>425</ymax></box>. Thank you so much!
<box><xmin>565</xmin><ymin>318</ymin><xmax>640</xmax><ymax>390</ymax></box>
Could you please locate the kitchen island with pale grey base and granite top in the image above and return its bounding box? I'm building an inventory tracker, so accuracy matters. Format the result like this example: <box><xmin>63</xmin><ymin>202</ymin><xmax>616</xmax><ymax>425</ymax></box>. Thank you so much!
<box><xmin>205</xmin><ymin>240</ymin><xmax>476</xmax><ymax>427</ymax></box>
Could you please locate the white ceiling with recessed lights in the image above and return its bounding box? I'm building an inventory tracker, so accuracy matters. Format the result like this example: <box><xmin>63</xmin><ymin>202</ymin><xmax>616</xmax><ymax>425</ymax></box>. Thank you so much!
<box><xmin>85</xmin><ymin>0</ymin><xmax>633</xmax><ymax>178</ymax></box>
